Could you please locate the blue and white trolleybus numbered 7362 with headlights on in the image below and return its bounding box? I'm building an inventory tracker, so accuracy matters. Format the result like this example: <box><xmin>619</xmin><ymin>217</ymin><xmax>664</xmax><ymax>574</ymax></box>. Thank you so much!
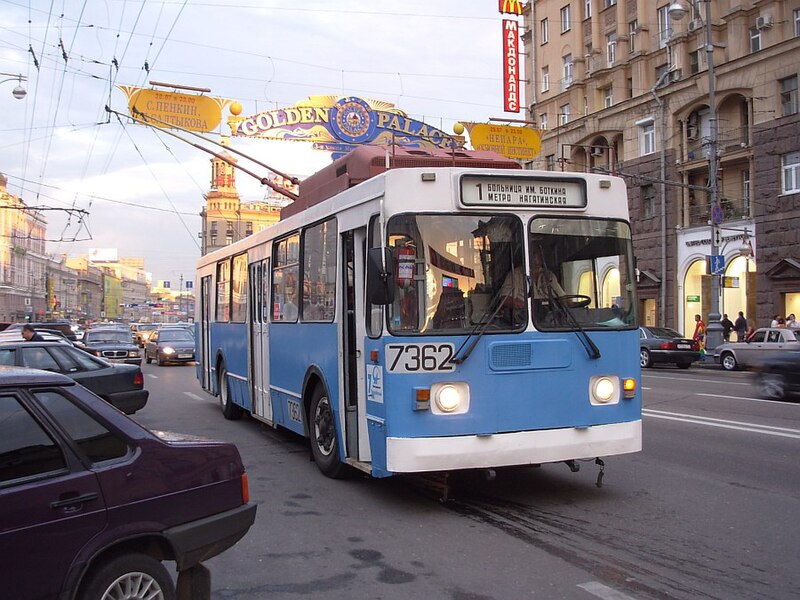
<box><xmin>196</xmin><ymin>149</ymin><xmax>641</xmax><ymax>477</ymax></box>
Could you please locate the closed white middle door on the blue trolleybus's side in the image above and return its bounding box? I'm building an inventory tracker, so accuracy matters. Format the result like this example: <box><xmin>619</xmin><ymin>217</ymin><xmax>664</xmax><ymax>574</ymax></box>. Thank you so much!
<box><xmin>248</xmin><ymin>259</ymin><xmax>272</xmax><ymax>423</ymax></box>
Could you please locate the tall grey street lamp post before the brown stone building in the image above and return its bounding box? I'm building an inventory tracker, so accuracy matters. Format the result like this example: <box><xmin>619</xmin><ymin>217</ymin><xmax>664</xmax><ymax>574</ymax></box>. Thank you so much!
<box><xmin>667</xmin><ymin>0</ymin><xmax>722</xmax><ymax>348</ymax></box>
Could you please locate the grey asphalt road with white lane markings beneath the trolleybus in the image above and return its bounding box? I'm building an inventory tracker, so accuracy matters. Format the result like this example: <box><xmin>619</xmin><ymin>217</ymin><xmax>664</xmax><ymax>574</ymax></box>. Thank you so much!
<box><xmin>136</xmin><ymin>365</ymin><xmax>800</xmax><ymax>600</ymax></box>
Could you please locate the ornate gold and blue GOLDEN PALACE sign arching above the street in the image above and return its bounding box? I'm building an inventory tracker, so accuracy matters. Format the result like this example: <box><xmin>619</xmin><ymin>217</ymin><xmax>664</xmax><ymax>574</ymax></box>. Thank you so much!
<box><xmin>228</xmin><ymin>96</ymin><xmax>454</xmax><ymax>153</ymax></box>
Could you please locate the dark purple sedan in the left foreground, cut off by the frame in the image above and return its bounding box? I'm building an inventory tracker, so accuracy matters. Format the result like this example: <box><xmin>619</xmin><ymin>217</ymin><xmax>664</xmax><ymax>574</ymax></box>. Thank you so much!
<box><xmin>0</xmin><ymin>367</ymin><xmax>256</xmax><ymax>600</ymax></box>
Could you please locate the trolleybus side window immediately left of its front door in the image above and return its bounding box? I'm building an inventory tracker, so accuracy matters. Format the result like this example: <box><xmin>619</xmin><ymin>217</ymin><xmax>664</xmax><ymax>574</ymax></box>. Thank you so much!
<box><xmin>301</xmin><ymin>219</ymin><xmax>336</xmax><ymax>322</ymax></box>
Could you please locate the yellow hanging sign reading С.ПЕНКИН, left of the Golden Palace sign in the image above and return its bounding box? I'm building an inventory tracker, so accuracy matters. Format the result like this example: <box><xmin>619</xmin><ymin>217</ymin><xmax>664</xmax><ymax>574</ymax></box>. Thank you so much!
<box><xmin>117</xmin><ymin>85</ymin><xmax>231</xmax><ymax>132</ymax></box>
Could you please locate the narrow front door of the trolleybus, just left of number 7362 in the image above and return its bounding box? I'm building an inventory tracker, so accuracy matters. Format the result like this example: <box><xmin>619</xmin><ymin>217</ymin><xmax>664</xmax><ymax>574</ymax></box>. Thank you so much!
<box><xmin>342</xmin><ymin>227</ymin><xmax>371</xmax><ymax>462</ymax></box>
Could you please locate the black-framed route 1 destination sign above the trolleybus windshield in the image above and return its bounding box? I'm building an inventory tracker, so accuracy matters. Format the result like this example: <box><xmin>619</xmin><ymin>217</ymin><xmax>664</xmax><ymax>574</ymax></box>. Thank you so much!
<box><xmin>461</xmin><ymin>175</ymin><xmax>586</xmax><ymax>208</ymax></box>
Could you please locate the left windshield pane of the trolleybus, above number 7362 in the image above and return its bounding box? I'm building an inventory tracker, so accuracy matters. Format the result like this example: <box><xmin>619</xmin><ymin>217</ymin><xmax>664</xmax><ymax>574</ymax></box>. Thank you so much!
<box><xmin>387</xmin><ymin>214</ymin><xmax>528</xmax><ymax>335</ymax></box>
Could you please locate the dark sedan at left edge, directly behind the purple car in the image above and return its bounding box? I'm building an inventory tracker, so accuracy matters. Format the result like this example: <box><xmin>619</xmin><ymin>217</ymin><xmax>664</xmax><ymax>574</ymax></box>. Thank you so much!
<box><xmin>0</xmin><ymin>339</ymin><xmax>150</xmax><ymax>415</ymax></box>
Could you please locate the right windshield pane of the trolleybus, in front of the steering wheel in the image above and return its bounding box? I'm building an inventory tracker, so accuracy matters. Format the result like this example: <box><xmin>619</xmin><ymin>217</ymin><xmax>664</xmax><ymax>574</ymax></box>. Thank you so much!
<box><xmin>529</xmin><ymin>217</ymin><xmax>637</xmax><ymax>330</ymax></box>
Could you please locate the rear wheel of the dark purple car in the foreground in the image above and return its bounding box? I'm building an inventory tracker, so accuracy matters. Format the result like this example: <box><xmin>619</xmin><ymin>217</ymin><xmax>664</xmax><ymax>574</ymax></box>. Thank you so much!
<box><xmin>78</xmin><ymin>554</ymin><xmax>175</xmax><ymax>600</ymax></box>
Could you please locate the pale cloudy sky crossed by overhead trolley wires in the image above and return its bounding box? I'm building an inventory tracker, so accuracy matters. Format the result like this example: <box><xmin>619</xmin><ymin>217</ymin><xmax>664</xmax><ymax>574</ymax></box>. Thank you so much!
<box><xmin>0</xmin><ymin>0</ymin><xmax>521</xmax><ymax>286</ymax></box>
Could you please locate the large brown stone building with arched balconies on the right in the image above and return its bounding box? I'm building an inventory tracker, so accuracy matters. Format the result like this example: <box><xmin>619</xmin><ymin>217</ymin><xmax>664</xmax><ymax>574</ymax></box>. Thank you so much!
<box><xmin>523</xmin><ymin>0</ymin><xmax>800</xmax><ymax>333</ymax></box>
